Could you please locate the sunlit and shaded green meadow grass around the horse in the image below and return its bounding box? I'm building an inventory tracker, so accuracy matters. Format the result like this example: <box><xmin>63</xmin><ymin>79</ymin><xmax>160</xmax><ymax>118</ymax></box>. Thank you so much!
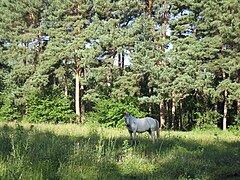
<box><xmin>0</xmin><ymin>123</ymin><xmax>240</xmax><ymax>180</ymax></box>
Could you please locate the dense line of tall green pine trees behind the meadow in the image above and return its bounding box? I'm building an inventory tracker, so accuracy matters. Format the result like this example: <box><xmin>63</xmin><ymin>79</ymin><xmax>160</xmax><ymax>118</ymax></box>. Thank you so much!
<box><xmin>0</xmin><ymin>0</ymin><xmax>240</xmax><ymax>130</ymax></box>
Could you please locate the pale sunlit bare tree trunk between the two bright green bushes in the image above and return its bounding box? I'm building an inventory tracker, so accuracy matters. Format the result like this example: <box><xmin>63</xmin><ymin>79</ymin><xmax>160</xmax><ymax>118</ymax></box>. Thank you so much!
<box><xmin>75</xmin><ymin>65</ymin><xmax>81</xmax><ymax>123</ymax></box>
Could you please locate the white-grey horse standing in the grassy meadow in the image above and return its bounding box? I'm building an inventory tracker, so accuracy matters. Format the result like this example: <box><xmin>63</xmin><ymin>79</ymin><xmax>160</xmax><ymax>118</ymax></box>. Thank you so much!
<box><xmin>123</xmin><ymin>113</ymin><xmax>160</xmax><ymax>145</ymax></box>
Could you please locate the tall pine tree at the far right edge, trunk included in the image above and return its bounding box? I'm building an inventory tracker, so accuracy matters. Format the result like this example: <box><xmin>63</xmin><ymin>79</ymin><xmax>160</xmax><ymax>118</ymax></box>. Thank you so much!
<box><xmin>197</xmin><ymin>0</ymin><xmax>239</xmax><ymax>130</ymax></box>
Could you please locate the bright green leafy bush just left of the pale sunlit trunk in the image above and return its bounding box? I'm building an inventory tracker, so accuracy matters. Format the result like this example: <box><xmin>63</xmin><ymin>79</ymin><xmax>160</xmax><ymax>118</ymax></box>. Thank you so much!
<box><xmin>26</xmin><ymin>95</ymin><xmax>75</xmax><ymax>123</ymax></box>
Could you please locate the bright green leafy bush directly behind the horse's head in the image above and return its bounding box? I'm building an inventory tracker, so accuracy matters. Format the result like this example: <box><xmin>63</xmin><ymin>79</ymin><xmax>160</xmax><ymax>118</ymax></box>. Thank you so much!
<box><xmin>87</xmin><ymin>99</ymin><xmax>146</xmax><ymax>127</ymax></box>
